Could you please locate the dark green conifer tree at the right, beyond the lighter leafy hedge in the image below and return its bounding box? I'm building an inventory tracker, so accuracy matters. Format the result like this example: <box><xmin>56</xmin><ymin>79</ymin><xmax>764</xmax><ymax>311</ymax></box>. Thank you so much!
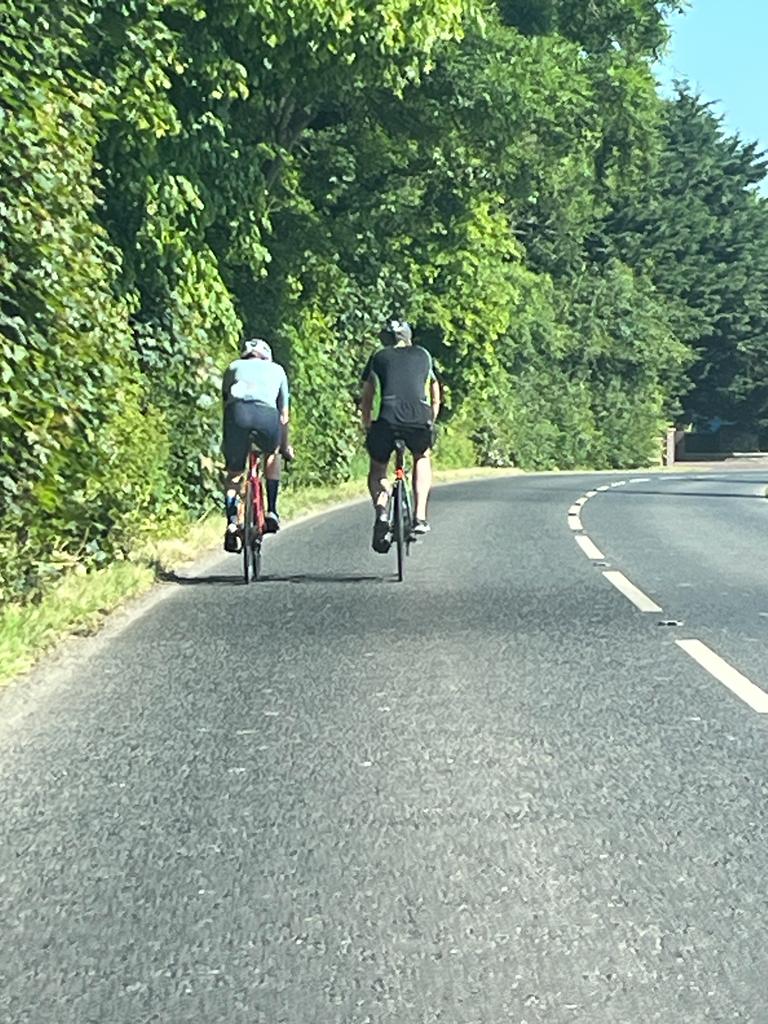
<box><xmin>607</xmin><ymin>87</ymin><xmax>768</xmax><ymax>430</ymax></box>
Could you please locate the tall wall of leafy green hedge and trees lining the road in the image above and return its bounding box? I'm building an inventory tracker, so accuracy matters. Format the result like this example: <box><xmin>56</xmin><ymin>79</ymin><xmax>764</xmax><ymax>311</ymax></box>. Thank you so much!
<box><xmin>0</xmin><ymin>0</ymin><xmax>768</xmax><ymax>600</ymax></box>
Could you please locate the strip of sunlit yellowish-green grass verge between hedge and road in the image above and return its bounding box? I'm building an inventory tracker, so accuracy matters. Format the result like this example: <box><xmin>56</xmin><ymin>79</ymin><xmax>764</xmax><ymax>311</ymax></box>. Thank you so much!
<box><xmin>0</xmin><ymin>469</ymin><xmax>514</xmax><ymax>686</ymax></box>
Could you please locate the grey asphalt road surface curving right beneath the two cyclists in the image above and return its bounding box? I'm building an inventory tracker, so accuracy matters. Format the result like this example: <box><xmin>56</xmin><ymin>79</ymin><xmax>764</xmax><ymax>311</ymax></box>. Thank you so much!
<box><xmin>0</xmin><ymin>467</ymin><xmax>768</xmax><ymax>1024</ymax></box>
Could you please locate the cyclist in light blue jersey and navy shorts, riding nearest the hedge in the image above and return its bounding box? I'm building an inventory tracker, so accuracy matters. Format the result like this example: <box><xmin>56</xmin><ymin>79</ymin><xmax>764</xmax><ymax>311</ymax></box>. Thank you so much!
<box><xmin>221</xmin><ymin>338</ymin><xmax>293</xmax><ymax>551</ymax></box>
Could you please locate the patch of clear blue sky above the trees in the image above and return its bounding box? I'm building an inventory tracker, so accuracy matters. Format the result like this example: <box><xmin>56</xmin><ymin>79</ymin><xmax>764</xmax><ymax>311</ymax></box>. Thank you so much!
<box><xmin>658</xmin><ymin>0</ymin><xmax>768</xmax><ymax>150</ymax></box>
